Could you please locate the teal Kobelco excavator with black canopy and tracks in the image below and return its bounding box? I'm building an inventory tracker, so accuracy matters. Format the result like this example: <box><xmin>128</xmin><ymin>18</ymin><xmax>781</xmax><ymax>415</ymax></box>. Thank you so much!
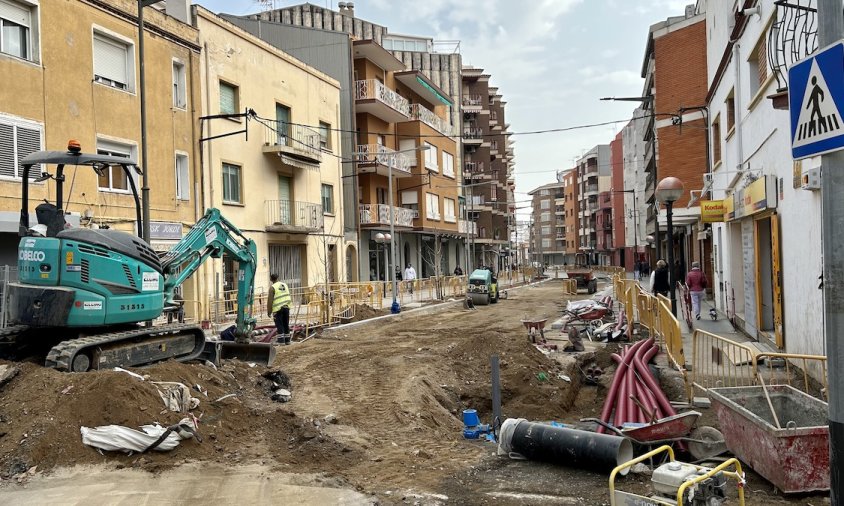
<box><xmin>0</xmin><ymin>141</ymin><xmax>273</xmax><ymax>372</ymax></box>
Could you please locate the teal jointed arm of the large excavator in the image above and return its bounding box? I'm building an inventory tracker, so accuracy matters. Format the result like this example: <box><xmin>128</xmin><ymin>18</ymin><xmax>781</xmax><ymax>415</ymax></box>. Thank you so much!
<box><xmin>161</xmin><ymin>208</ymin><xmax>258</xmax><ymax>341</ymax></box>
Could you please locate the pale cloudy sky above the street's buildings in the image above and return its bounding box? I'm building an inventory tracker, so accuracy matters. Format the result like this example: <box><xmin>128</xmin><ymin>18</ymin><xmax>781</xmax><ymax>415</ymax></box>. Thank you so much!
<box><xmin>194</xmin><ymin>0</ymin><xmax>694</xmax><ymax>215</ymax></box>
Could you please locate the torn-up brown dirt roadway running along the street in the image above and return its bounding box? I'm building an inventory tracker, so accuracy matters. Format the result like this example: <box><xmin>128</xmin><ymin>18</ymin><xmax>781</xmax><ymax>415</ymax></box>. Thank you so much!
<box><xmin>0</xmin><ymin>282</ymin><xmax>832</xmax><ymax>504</ymax></box>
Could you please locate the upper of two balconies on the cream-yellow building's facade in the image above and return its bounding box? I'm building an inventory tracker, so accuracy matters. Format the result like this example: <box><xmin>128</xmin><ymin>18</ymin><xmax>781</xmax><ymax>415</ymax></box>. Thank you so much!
<box><xmin>262</xmin><ymin>121</ymin><xmax>322</xmax><ymax>169</ymax></box>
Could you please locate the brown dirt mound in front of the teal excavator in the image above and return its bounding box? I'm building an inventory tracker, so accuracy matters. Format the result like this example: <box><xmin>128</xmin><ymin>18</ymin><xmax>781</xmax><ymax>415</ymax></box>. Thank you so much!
<box><xmin>0</xmin><ymin>361</ymin><xmax>359</xmax><ymax>477</ymax></box>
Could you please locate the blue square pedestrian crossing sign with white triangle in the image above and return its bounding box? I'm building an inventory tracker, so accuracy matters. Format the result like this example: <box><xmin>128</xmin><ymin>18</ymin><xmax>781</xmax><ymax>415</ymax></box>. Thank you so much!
<box><xmin>788</xmin><ymin>41</ymin><xmax>844</xmax><ymax>160</ymax></box>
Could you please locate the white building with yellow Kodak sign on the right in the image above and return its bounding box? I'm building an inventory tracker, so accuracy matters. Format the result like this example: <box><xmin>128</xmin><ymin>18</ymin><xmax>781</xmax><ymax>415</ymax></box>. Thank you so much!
<box><xmin>702</xmin><ymin>2</ymin><xmax>829</xmax><ymax>360</ymax></box>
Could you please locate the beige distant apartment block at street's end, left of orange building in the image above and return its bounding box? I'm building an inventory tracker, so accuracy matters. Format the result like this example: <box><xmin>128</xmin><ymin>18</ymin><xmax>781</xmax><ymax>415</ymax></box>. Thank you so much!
<box><xmin>528</xmin><ymin>180</ymin><xmax>566</xmax><ymax>265</ymax></box>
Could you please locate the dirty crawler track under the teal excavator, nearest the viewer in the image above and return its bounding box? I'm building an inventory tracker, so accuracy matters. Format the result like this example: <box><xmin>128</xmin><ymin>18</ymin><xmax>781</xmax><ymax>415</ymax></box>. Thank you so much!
<box><xmin>45</xmin><ymin>324</ymin><xmax>205</xmax><ymax>372</ymax></box>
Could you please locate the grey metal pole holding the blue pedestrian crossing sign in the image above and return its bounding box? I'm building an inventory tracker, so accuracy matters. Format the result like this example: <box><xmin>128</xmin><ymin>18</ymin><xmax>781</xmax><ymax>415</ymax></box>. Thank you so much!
<box><xmin>818</xmin><ymin>0</ymin><xmax>844</xmax><ymax>506</ymax></box>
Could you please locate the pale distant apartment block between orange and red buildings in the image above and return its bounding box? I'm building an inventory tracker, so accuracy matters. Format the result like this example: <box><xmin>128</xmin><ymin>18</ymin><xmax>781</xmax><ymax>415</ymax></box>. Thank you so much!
<box><xmin>576</xmin><ymin>144</ymin><xmax>612</xmax><ymax>265</ymax></box>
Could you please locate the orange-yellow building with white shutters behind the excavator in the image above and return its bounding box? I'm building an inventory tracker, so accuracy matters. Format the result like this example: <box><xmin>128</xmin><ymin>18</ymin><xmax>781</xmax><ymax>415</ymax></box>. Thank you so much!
<box><xmin>0</xmin><ymin>0</ymin><xmax>204</xmax><ymax>302</ymax></box>
